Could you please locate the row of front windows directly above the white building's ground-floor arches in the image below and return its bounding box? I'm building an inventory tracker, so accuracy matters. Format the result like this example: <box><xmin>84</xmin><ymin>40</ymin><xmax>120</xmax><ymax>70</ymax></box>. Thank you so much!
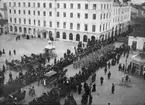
<box><xmin>10</xmin><ymin>18</ymin><xmax>96</xmax><ymax>32</ymax></box>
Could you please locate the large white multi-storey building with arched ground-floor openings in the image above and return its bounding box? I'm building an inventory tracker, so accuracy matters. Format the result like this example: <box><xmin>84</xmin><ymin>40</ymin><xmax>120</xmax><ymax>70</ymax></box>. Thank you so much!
<box><xmin>8</xmin><ymin>0</ymin><xmax>131</xmax><ymax>42</ymax></box>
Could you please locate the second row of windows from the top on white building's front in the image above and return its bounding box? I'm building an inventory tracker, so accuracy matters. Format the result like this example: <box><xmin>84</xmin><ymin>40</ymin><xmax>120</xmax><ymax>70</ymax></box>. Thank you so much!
<box><xmin>9</xmin><ymin>9</ymin><xmax>98</xmax><ymax>19</ymax></box>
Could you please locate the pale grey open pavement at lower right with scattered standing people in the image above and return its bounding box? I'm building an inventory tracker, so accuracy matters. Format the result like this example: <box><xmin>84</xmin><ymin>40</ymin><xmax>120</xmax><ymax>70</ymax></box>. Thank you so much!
<box><xmin>61</xmin><ymin>55</ymin><xmax>145</xmax><ymax>105</ymax></box>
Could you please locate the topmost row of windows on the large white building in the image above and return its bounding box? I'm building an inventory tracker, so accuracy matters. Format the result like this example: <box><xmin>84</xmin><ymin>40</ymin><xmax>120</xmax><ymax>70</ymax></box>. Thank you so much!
<box><xmin>9</xmin><ymin>2</ymin><xmax>111</xmax><ymax>10</ymax></box>
